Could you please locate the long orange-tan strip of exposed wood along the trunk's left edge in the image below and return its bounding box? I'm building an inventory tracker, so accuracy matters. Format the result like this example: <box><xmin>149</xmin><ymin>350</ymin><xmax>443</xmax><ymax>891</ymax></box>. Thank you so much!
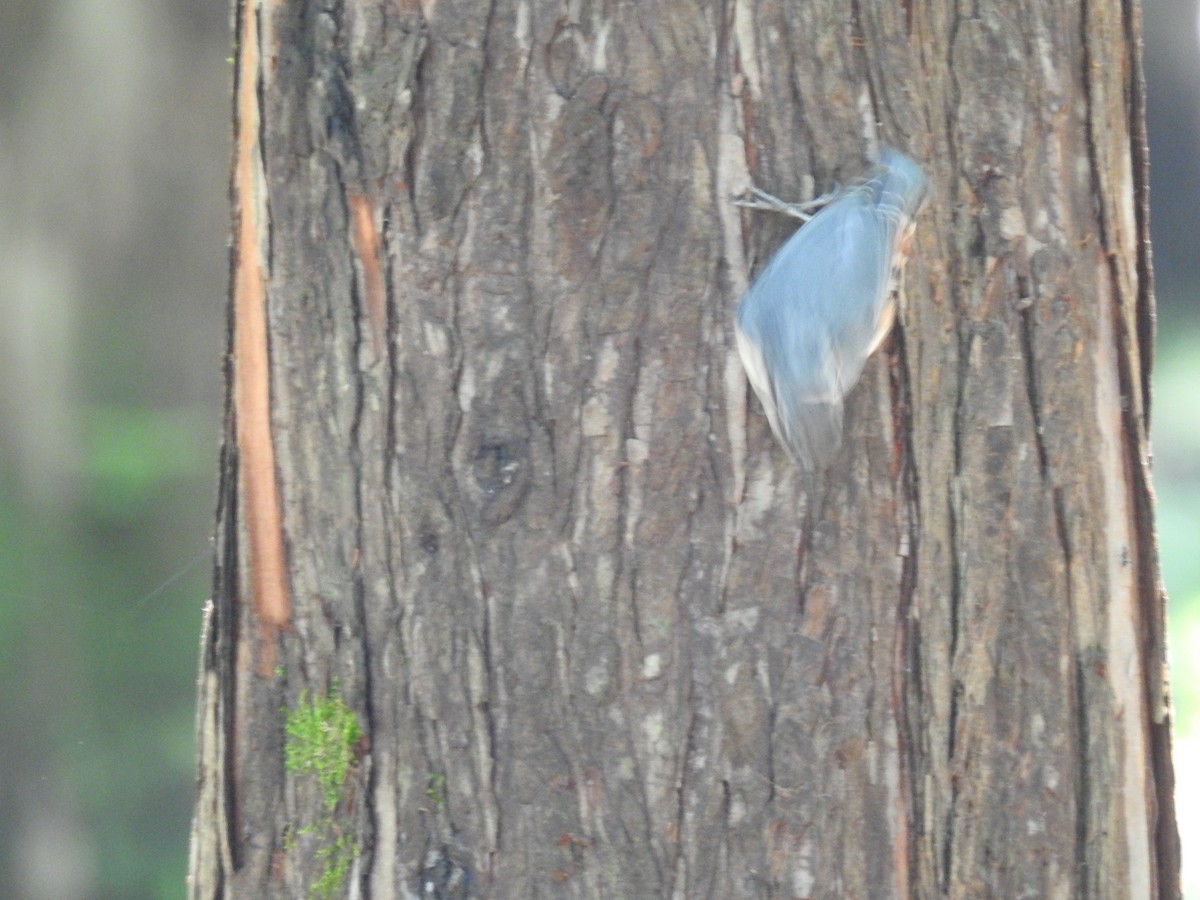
<box><xmin>233</xmin><ymin>5</ymin><xmax>292</xmax><ymax>676</ymax></box>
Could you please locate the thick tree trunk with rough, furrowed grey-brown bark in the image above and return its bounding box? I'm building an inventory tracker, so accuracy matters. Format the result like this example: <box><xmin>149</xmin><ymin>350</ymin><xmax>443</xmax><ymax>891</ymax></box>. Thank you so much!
<box><xmin>192</xmin><ymin>0</ymin><xmax>1178</xmax><ymax>898</ymax></box>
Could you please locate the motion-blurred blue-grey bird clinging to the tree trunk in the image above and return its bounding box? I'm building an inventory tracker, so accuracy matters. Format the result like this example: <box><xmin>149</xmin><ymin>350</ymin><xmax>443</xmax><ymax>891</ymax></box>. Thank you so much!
<box><xmin>737</xmin><ymin>149</ymin><xmax>929</xmax><ymax>485</ymax></box>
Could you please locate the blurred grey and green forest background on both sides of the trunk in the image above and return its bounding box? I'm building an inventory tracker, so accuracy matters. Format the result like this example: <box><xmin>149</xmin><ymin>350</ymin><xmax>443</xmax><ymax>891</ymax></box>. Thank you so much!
<box><xmin>0</xmin><ymin>0</ymin><xmax>1200</xmax><ymax>900</ymax></box>
